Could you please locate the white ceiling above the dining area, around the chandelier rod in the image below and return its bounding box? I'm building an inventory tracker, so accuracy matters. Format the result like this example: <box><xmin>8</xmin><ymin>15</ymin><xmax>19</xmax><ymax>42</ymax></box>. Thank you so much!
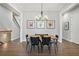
<box><xmin>12</xmin><ymin>3</ymin><xmax>71</xmax><ymax>12</ymax></box>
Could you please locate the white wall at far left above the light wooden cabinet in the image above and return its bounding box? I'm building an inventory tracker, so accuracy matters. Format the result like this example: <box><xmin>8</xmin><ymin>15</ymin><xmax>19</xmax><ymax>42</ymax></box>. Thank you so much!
<box><xmin>0</xmin><ymin>5</ymin><xmax>11</xmax><ymax>29</ymax></box>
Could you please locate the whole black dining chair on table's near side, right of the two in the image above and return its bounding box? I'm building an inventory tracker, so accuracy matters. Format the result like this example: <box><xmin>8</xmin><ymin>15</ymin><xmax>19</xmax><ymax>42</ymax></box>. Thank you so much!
<box><xmin>41</xmin><ymin>36</ymin><xmax>51</xmax><ymax>53</ymax></box>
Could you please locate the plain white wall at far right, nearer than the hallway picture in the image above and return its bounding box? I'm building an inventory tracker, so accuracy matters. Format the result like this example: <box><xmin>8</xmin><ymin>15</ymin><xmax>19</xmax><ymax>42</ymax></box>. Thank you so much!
<box><xmin>70</xmin><ymin>7</ymin><xmax>79</xmax><ymax>44</ymax></box>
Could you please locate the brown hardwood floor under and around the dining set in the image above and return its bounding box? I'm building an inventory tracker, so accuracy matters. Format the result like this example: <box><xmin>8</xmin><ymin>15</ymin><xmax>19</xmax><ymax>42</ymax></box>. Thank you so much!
<box><xmin>0</xmin><ymin>40</ymin><xmax>79</xmax><ymax>56</ymax></box>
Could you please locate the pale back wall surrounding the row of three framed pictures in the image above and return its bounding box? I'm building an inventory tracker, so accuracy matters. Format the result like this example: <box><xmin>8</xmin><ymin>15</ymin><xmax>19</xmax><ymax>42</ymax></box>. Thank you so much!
<box><xmin>22</xmin><ymin>11</ymin><xmax>60</xmax><ymax>41</ymax></box>
